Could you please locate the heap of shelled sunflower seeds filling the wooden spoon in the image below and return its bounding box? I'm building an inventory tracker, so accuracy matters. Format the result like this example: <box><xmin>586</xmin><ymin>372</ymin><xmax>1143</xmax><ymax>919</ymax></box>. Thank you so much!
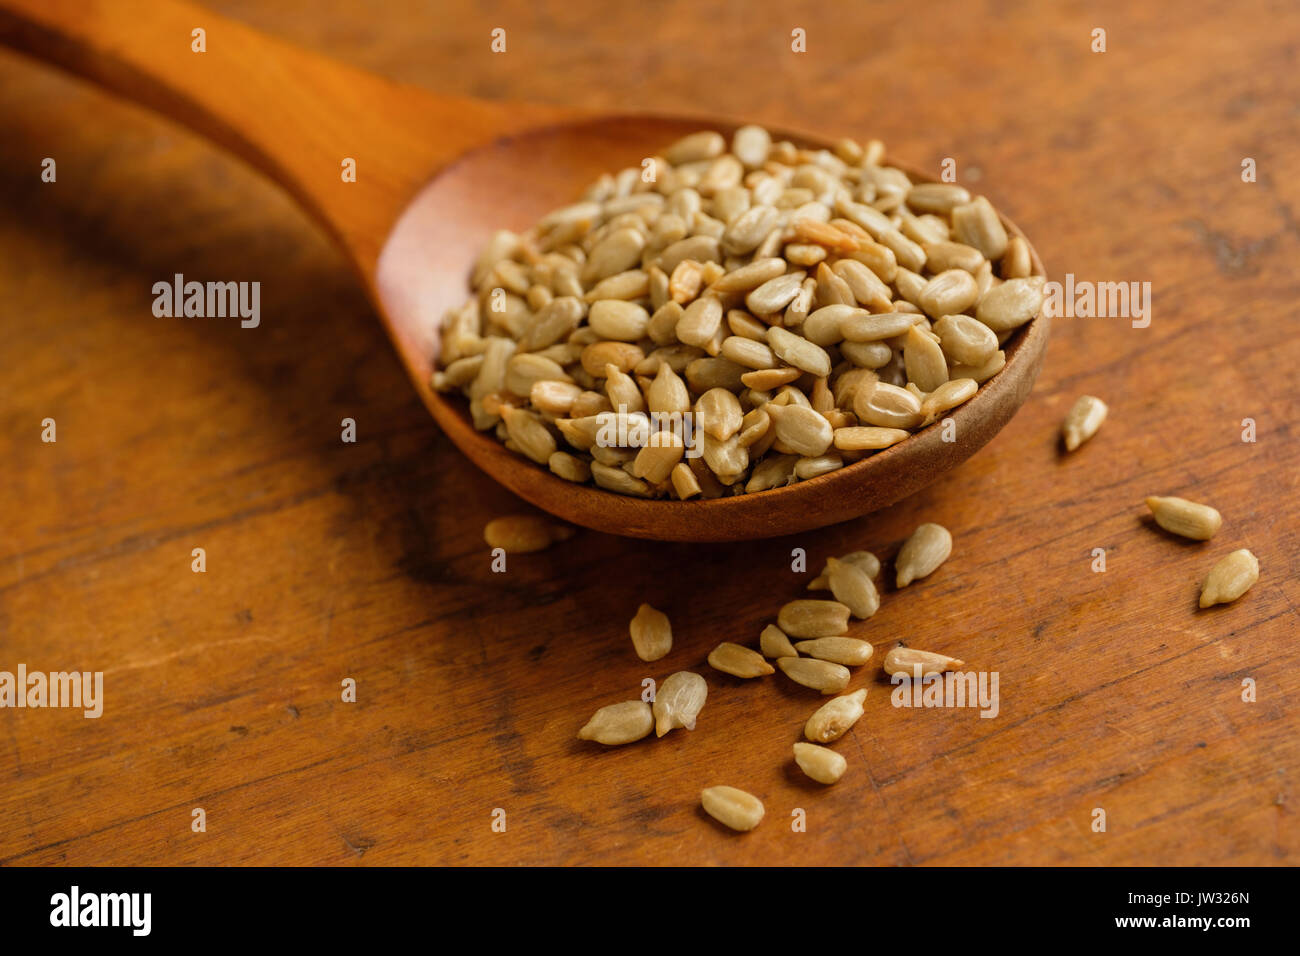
<box><xmin>433</xmin><ymin>126</ymin><xmax>1044</xmax><ymax>499</ymax></box>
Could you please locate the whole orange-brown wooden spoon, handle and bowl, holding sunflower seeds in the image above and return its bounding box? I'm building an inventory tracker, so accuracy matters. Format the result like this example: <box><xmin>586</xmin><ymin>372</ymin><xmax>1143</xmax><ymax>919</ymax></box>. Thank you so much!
<box><xmin>0</xmin><ymin>0</ymin><xmax>1048</xmax><ymax>541</ymax></box>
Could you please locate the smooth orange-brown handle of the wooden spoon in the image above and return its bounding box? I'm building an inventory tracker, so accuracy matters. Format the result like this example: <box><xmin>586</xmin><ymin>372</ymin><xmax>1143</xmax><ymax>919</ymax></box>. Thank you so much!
<box><xmin>0</xmin><ymin>0</ymin><xmax>574</xmax><ymax>277</ymax></box>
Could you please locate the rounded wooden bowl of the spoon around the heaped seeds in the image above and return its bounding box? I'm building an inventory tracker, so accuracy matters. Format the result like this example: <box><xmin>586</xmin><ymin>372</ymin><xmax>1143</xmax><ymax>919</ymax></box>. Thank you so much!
<box><xmin>377</xmin><ymin>116</ymin><xmax>1048</xmax><ymax>541</ymax></box>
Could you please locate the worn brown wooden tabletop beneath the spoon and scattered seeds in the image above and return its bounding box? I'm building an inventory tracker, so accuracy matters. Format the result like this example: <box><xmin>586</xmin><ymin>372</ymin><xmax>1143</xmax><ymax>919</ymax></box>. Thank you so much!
<box><xmin>0</xmin><ymin>1</ymin><xmax>1300</xmax><ymax>865</ymax></box>
